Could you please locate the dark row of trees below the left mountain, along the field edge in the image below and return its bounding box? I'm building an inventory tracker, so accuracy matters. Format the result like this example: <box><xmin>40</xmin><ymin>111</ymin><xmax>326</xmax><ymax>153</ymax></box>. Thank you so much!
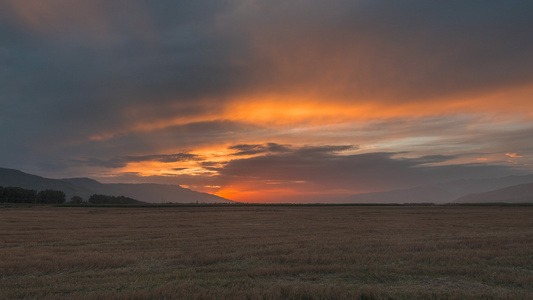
<box><xmin>0</xmin><ymin>186</ymin><xmax>143</xmax><ymax>204</ymax></box>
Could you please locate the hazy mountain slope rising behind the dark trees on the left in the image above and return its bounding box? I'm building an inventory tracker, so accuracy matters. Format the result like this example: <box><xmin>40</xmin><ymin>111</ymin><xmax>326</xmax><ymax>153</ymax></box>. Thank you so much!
<box><xmin>0</xmin><ymin>168</ymin><xmax>233</xmax><ymax>203</ymax></box>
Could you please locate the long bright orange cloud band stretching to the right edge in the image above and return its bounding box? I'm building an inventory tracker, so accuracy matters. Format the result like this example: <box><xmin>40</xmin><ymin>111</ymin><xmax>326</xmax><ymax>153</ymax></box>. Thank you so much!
<box><xmin>102</xmin><ymin>81</ymin><xmax>533</xmax><ymax>140</ymax></box>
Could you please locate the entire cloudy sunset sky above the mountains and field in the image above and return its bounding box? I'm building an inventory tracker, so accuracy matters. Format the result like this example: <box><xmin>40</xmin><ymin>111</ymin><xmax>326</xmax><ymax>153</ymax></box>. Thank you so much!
<box><xmin>0</xmin><ymin>0</ymin><xmax>533</xmax><ymax>202</ymax></box>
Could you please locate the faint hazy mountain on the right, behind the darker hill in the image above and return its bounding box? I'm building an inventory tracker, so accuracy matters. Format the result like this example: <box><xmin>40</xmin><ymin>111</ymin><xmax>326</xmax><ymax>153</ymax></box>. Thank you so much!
<box><xmin>338</xmin><ymin>174</ymin><xmax>533</xmax><ymax>203</ymax></box>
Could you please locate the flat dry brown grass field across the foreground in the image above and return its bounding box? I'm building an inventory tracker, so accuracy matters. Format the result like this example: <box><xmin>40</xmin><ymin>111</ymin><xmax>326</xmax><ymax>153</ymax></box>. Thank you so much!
<box><xmin>0</xmin><ymin>206</ymin><xmax>533</xmax><ymax>299</ymax></box>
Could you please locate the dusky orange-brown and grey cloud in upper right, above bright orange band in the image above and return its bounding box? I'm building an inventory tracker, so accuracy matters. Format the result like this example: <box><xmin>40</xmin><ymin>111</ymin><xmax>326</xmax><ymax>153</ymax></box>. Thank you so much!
<box><xmin>221</xmin><ymin>0</ymin><xmax>533</xmax><ymax>103</ymax></box>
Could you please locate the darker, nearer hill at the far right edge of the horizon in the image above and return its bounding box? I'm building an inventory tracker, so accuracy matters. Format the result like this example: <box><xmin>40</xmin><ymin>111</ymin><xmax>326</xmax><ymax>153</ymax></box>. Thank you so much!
<box><xmin>454</xmin><ymin>183</ymin><xmax>533</xmax><ymax>203</ymax></box>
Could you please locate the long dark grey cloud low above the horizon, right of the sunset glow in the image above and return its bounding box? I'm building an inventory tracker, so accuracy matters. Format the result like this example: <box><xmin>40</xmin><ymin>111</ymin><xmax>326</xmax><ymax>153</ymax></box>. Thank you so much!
<box><xmin>211</xmin><ymin>146</ymin><xmax>516</xmax><ymax>192</ymax></box>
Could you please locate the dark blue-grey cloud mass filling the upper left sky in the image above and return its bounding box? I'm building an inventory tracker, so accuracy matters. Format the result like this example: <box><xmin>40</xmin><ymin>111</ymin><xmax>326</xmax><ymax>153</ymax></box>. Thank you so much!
<box><xmin>0</xmin><ymin>0</ymin><xmax>246</xmax><ymax>146</ymax></box>
